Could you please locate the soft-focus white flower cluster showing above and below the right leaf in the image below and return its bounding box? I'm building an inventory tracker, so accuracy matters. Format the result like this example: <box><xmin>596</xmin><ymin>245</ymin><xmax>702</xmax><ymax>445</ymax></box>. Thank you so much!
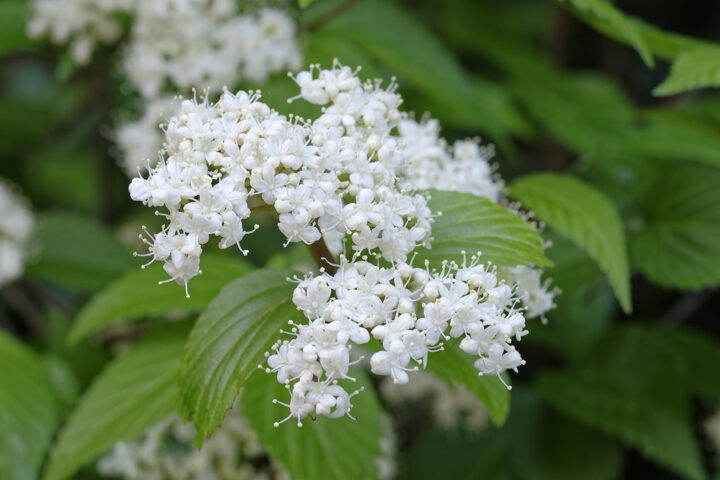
<box><xmin>398</xmin><ymin>119</ymin><xmax>558</xmax><ymax>320</ymax></box>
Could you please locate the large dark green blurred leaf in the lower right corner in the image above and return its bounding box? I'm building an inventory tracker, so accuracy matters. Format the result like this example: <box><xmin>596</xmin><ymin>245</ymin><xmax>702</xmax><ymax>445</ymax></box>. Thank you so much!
<box><xmin>537</xmin><ymin>328</ymin><xmax>705</xmax><ymax>479</ymax></box>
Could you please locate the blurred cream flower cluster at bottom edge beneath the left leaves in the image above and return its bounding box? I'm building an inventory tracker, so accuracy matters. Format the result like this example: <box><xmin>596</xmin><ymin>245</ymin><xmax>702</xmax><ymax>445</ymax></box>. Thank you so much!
<box><xmin>97</xmin><ymin>407</ymin><xmax>290</xmax><ymax>480</ymax></box>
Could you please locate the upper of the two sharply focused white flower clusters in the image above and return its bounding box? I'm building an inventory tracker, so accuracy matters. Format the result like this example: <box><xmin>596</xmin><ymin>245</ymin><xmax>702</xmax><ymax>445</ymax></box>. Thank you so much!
<box><xmin>130</xmin><ymin>64</ymin><xmax>432</xmax><ymax>296</ymax></box>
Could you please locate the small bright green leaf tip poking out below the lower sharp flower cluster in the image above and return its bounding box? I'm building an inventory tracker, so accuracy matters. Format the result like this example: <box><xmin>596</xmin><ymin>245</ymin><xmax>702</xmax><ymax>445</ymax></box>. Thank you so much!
<box><xmin>427</xmin><ymin>345</ymin><xmax>510</xmax><ymax>425</ymax></box>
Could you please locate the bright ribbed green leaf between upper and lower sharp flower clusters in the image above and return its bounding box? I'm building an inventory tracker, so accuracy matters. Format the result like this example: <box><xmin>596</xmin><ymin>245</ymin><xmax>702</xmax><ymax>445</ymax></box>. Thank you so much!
<box><xmin>416</xmin><ymin>190</ymin><xmax>550</xmax><ymax>267</ymax></box>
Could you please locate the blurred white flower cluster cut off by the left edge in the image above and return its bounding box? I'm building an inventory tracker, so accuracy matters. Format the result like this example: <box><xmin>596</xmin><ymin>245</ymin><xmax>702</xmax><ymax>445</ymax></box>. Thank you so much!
<box><xmin>0</xmin><ymin>182</ymin><xmax>34</xmax><ymax>287</ymax></box>
